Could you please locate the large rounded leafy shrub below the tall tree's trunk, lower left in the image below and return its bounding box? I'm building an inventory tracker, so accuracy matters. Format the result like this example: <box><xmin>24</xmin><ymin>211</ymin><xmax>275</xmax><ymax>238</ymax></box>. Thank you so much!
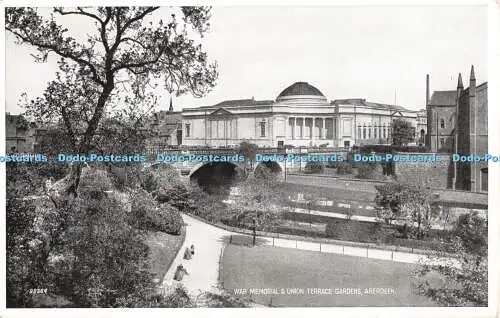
<box><xmin>53</xmin><ymin>185</ymin><xmax>153</xmax><ymax>307</ymax></box>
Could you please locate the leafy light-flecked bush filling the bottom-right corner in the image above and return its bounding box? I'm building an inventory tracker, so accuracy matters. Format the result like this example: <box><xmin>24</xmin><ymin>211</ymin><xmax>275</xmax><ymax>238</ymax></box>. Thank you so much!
<box><xmin>417</xmin><ymin>212</ymin><xmax>488</xmax><ymax>306</ymax></box>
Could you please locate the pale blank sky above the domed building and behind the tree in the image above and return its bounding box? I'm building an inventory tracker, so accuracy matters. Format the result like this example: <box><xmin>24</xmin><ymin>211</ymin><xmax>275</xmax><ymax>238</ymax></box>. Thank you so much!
<box><xmin>5</xmin><ymin>6</ymin><xmax>488</xmax><ymax>114</ymax></box>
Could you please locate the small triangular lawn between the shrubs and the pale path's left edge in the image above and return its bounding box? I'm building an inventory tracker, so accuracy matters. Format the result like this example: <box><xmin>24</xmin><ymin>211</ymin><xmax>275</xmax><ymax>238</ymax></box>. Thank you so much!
<box><xmin>144</xmin><ymin>231</ymin><xmax>185</xmax><ymax>282</ymax></box>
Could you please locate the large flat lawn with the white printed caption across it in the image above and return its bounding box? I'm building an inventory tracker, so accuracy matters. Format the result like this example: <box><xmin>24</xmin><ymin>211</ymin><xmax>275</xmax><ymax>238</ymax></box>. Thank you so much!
<box><xmin>222</xmin><ymin>244</ymin><xmax>440</xmax><ymax>307</ymax></box>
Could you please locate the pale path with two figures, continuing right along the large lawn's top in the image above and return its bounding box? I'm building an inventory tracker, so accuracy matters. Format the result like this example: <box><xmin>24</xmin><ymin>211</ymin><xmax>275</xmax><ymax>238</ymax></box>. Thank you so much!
<box><xmin>162</xmin><ymin>214</ymin><xmax>456</xmax><ymax>298</ymax></box>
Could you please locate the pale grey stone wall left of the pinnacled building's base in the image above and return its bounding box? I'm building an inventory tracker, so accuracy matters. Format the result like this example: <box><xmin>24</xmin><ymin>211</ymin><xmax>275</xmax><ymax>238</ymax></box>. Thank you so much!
<box><xmin>394</xmin><ymin>152</ymin><xmax>453</xmax><ymax>189</ymax></box>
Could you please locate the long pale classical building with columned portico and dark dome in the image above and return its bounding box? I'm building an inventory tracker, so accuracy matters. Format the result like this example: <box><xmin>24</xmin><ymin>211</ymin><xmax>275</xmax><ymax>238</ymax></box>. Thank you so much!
<box><xmin>182</xmin><ymin>82</ymin><xmax>417</xmax><ymax>147</ymax></box>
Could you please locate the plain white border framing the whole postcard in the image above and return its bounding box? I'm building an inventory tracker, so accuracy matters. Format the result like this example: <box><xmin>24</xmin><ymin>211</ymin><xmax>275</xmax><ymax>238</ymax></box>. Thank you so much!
<box><xmin>0</xmin><ymin>0</ymin><xmax>500</xmax><ymax>318</ymax></box>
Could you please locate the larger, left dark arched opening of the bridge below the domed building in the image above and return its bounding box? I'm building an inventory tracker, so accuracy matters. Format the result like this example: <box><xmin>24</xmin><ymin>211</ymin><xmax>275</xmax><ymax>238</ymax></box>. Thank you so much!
<box><xmin>189</xmin><ymin>162</ymin><xmax>245</xmax><ymax>196</ymax></box>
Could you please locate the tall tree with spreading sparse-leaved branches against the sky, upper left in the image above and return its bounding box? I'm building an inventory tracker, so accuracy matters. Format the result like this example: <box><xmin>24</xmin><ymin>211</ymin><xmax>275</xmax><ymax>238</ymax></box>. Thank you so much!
<box><xmin>5</xmin><ymin>7</ymin><xmax>217</xmax><ymax>194</ymax></box>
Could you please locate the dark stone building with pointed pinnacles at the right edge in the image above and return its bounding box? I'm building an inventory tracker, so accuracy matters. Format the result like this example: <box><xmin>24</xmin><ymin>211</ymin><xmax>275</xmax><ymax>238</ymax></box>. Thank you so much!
<box><xmin>426</xmin><ymin>66</ymin><xmax>488</xmax><ymax>191</ymax></box>
